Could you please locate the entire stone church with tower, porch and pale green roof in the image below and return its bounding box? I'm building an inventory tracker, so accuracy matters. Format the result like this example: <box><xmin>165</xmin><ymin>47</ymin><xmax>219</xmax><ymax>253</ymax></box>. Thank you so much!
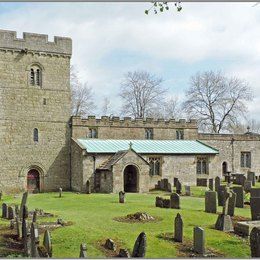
<box><xmin>0</xmin><ymin>30</ymin><xmax>260</xmax><ymax>193</ymax></box>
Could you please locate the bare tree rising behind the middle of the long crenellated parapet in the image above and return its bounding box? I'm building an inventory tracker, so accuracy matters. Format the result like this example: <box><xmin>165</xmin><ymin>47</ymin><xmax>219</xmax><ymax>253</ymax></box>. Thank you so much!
<box><xmin>119</xmin><ymin>71</ymin><xmax>167</xmax><ymax>118</ymax></box>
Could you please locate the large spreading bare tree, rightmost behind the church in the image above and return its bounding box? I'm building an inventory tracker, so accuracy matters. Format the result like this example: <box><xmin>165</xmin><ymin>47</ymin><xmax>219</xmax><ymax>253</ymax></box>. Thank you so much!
<box><xmin>183</xmin><ymin>71</ymin><xmax>252</xmax><ymax>133</ymax></box>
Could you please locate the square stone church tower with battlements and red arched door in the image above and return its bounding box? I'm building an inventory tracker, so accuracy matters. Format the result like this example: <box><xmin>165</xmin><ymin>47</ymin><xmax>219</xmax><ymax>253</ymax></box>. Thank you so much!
<box><xmin>0</xmin><ymin>30</ymin><xmax>72</xmax><ymax>192</ymax></box>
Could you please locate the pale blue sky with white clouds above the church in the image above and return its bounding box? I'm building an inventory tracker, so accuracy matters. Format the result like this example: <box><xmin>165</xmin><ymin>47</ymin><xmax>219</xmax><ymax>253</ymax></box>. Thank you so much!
<box><xmin>0</xmin><ymin>2</ymin><xmax>260</xmax><ymax>120</ymax></box>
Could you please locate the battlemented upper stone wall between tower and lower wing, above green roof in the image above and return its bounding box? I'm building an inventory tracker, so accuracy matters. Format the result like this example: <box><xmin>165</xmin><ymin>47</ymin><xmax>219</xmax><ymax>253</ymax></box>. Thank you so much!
<box><xmin>72</xmin><ymin>116</ymin><xmax>198</xmax><ymax>140</ymax></box>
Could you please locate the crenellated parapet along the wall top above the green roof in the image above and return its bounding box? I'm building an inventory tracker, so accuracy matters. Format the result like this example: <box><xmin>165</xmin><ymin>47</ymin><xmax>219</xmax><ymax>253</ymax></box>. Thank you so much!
<box><xmin>72</xmin><ymin>116</ymin><xmax>197</xmax><ymax>129</ymax></box>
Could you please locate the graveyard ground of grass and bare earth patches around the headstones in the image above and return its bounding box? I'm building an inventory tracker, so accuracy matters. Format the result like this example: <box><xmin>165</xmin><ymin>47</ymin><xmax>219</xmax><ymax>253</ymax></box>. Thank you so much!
<box><xmin>0</xmin><ymin>183</ymin><xmax>260</xmax><ymax>258</ymax></box>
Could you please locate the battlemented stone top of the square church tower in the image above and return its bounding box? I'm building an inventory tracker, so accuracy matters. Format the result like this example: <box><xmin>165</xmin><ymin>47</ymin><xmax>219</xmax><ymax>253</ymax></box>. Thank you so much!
<box><xmin>0</xmin><ymin>30</ymin><xmax>72</xmax><ymax>56</ymax></box>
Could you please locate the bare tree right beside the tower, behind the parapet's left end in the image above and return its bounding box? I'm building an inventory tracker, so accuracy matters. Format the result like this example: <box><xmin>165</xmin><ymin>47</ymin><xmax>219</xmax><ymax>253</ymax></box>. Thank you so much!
<box><xmin>70</xmin><ymin>67</ymin><xmax>96</xmax><ymax>116</ymax></box>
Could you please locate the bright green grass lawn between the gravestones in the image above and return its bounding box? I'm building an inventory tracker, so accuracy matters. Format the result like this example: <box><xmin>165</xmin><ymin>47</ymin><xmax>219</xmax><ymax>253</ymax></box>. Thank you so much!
<box><xmin>0</xmin><ymin>190</ymin><xmax>250</xmax><ymax>258</ymax></box>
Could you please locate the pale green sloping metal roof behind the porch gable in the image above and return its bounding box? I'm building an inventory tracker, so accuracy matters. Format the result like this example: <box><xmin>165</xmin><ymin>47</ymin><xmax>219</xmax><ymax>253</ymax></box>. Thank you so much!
<box><xmin>77</xmin><ymin>139</ymin><xmax>218</xmax><ymax>154</ymax></box>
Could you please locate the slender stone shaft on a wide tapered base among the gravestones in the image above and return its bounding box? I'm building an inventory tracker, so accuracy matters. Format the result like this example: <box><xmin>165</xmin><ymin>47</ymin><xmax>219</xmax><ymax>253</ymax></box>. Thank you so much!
<box><xmin>215</xmin><ymin>187</ymin><xmax>234</xmax><ymax>232</ymax></box>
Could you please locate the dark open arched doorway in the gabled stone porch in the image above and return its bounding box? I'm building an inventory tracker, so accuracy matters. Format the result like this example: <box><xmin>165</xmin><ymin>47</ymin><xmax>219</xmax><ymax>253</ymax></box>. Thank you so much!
<box><xmin>124</xmin><ymin>165</ymin><xmax>138</xmax><ymax>192</ymax></box>
